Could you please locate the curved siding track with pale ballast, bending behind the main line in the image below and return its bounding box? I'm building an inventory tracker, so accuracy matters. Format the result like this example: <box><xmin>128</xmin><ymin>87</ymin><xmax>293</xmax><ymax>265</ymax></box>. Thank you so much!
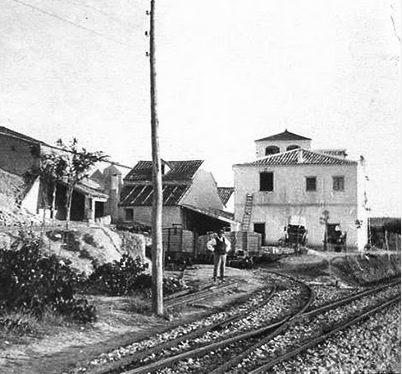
<box><xmin>90</xmin><ymin>273</ymin><xmax>313</xmax><ymax>374</ymax></box>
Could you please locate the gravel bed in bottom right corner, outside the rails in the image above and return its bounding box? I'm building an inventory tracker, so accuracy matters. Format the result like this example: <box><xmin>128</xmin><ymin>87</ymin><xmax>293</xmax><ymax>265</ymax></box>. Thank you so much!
<box><xmin>272</xmin><ymin>304</ymin><xmax>401</xmax><ymax>374</ymax></box>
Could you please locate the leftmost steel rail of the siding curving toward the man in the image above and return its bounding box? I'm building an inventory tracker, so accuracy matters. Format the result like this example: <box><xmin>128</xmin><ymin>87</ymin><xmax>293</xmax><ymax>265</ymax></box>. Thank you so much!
<box><xmin>90</xmin><ymin>287</ymin><xmax>277</xmax><ymax>374</ymax></box>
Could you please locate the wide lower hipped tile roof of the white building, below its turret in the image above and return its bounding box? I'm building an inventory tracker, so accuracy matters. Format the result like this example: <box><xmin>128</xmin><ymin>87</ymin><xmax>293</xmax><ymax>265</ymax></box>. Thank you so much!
<box><xmin>240</xmin><ymin>148</ymin><xmax>357</xmax><ymax>166</ymax></box>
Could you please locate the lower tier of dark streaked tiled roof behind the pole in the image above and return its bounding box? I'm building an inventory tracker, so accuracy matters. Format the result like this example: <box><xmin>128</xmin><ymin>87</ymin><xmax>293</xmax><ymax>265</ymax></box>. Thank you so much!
<box><xmin>120</xmin><ymin>184</ymin><xmax>190</xmax><ymax>206</ymax></box>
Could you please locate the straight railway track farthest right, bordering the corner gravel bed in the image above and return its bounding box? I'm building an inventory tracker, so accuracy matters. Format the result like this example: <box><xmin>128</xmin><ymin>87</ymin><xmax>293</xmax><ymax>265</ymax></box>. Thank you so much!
<box><xmin>210</xmin><ymin>282</ymin><xmax>400</xmax><ymax>374</ymax></box>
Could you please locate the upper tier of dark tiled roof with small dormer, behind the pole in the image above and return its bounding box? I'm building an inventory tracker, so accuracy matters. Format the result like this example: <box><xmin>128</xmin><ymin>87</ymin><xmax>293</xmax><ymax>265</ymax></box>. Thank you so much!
<box><xmin>124</xmin><ymin>160</ymin><xmax>204</xmax><ymax>181</ymax></box>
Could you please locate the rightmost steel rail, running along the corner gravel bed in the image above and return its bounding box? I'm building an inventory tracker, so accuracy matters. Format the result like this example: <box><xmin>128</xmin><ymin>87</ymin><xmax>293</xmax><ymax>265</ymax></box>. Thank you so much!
<box><xmin>249</xmin><ymin>296</ymin><xmax>401</xmax><ymax>374</ymax></box>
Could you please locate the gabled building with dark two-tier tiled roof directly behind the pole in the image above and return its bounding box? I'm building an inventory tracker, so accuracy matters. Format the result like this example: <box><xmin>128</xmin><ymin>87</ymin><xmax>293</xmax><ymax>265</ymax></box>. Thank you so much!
<box><xmin>119</xmin><ymin>160</ymin><xmax>236</xmax><ymax>235</ymax></box>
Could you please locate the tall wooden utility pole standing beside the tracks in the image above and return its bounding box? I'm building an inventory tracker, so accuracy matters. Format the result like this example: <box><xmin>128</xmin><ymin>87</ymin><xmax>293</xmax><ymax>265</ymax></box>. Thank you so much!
<box><xmin>149</xmin><ymin>0</ymin><xmax>163</xmax><ymax>315</ymax></box>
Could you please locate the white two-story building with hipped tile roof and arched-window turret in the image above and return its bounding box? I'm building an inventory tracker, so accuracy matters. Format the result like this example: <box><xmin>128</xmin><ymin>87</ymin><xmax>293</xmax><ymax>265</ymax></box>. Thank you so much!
<box><xmin>233</xmin><ymin>130</ymin><xmax>367</xmax><ymax>250</ymax></box>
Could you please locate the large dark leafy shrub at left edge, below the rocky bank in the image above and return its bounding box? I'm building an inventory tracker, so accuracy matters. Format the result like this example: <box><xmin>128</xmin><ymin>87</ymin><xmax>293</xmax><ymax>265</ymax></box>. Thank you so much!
<box><xmin>0</xmin><ymin>238</ymin><xmax>96</xmax><ymax>322</ymax></box>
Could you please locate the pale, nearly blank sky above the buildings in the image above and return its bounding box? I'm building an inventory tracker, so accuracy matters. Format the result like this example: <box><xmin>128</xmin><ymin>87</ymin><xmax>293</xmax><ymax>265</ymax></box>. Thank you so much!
<box><xmin>0</xmin><ymin>0</ymin><xmax>402</xmax><ymax>216</ymax></box>
